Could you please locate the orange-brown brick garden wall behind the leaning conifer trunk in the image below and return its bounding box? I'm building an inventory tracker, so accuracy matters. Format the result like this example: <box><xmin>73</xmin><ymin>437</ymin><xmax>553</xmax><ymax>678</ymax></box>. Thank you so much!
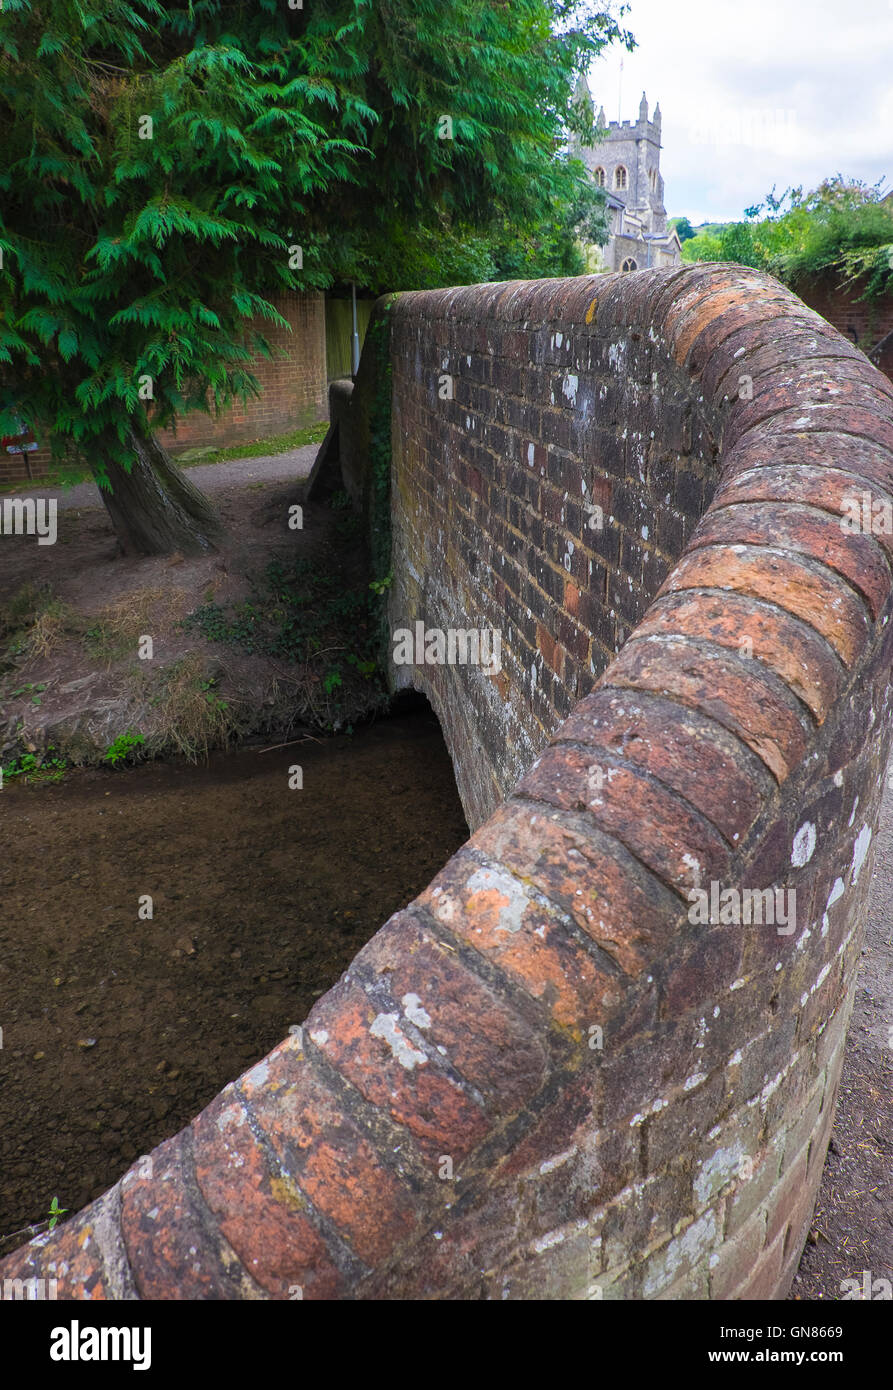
<box><xmin>0</xmin><ymin>292</ymin><xmax>328</xmax><ymax>484</ymax></box>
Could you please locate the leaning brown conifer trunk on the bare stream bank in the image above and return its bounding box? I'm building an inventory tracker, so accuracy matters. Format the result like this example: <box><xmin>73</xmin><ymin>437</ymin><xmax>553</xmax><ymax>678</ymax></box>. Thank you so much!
<box><xmin>91</xmin><ymin>430</ymin><xmax>224</xmax><ymax>555</ymax></box>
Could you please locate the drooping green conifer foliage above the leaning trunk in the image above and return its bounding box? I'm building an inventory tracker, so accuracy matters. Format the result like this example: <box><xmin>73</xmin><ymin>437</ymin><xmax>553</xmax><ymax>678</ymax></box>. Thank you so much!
<box><xmin>0</xmin><ymin>0</ymin><xmax>633</xmax><ymax>482</ymax></box>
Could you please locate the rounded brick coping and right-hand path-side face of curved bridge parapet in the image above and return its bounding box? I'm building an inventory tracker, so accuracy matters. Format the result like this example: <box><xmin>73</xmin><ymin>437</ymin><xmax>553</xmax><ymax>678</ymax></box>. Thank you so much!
<box><xmin>0</xmin><ymin>265</ymin><xmax>893</xmax><ymax>1298</ymax></box>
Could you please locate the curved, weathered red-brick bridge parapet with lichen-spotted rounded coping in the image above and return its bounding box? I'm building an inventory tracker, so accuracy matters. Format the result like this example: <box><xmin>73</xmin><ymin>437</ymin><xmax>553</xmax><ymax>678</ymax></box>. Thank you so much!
<box><xmin>0</xmin><ymin>265</ymin><xmax>893</xmax><ymax>1300</ymax></box>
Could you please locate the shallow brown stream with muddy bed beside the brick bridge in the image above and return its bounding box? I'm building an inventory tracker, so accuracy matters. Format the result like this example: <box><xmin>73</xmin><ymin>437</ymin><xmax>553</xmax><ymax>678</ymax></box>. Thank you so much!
<box><xmin>0</xmin><ymin>710</ymin><xmax>467</xmax><ymax>1254</ymax></box>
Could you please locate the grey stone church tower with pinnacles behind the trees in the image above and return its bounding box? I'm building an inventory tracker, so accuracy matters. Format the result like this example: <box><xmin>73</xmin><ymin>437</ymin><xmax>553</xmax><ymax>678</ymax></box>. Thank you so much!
<box><xmin>572</xmin><ymin>78</ymin><xmax>682</xmax><ymax>270</ymax></box>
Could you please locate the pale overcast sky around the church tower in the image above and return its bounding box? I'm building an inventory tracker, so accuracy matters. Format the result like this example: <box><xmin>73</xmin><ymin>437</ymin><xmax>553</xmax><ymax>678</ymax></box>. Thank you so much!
<box><xmin>590</xmin><ymin>0</ymin><xmax>893</xmax><ymax>225</ymax></box>
